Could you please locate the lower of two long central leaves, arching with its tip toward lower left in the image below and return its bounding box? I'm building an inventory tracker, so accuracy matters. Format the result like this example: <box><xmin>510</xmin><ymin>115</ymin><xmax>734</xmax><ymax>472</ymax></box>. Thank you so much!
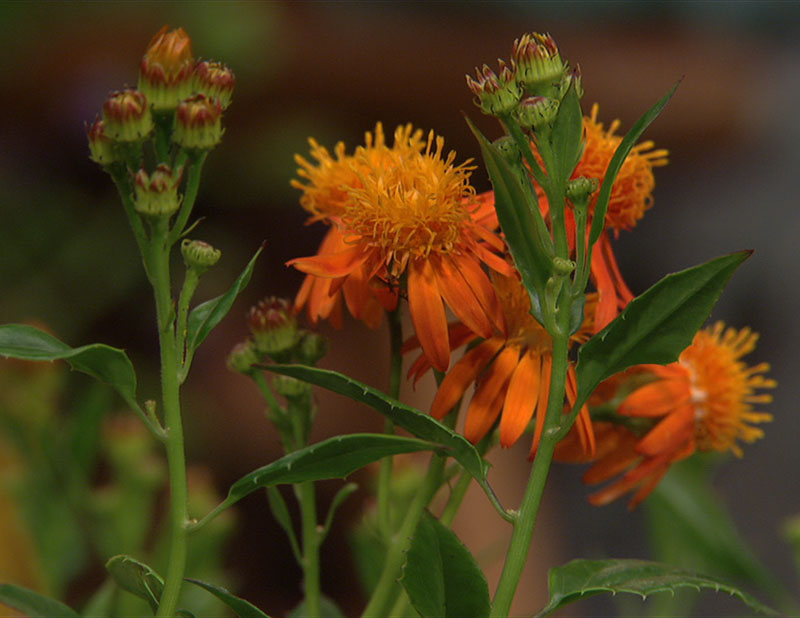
<box><xmin>198</xmin><ymin>433</ymin><xmax>438</xmax><ymax>527</ymax></box>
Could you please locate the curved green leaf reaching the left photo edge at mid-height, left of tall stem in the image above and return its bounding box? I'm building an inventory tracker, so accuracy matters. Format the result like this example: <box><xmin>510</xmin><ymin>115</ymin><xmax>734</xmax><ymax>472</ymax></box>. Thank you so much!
<box><xmin>0</xmin><ymin>324</ymin><xmax>141</xmax><ymax>412</ymax></box>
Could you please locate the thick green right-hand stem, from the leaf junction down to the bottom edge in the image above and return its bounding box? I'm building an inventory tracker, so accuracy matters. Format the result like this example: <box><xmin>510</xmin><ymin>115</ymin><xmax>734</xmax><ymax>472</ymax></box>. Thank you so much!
<box><xmin>490</xmin><ymin>328</ymin><xmax>569</xmax><ymax>618</ymax></box>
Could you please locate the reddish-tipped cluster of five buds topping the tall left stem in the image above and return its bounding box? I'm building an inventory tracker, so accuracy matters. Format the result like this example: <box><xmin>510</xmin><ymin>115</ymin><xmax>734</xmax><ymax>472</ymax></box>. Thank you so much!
<box><xmin>87</xmin><ymin>26</ymin><xmax>236</xmax><ymax>168</ymax></box>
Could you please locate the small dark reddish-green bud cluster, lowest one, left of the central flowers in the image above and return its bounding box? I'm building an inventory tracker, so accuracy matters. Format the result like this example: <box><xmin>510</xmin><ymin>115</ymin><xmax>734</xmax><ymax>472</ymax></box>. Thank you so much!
<box><xmin>228</xmin><ymin>296</ymin><xmax>328</xmax><ymax>373</ymax></box>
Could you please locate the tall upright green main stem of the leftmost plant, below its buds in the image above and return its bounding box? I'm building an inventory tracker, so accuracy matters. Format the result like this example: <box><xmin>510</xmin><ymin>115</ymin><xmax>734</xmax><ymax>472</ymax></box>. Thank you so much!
<box><xmin>150</xmin><ymin>220</ymin><xmax>189</xmax><ymax>616</ymax></box>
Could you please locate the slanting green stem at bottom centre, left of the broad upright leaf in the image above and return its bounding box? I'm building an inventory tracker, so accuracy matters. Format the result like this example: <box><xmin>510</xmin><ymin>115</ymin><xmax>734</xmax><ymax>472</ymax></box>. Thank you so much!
<box><xmin>361</xmin><ymin>455</ymin><xmax>445</xmax><ymax>618</ymax></box>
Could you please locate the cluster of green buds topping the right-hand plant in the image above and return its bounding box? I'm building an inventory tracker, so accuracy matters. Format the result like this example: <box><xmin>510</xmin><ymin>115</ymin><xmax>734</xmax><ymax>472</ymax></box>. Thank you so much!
<box><xmin>467</xmin><ymin>33</ymin><xmax>582</xmax><ymax>131</ymax></box>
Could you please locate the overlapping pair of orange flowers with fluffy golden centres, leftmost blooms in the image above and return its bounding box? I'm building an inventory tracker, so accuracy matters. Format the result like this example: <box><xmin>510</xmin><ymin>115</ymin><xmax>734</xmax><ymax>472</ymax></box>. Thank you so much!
<box><xmin>288</xmin><ymin>126</ymin><xmax>511</xmax><ymax>371</ymax></box>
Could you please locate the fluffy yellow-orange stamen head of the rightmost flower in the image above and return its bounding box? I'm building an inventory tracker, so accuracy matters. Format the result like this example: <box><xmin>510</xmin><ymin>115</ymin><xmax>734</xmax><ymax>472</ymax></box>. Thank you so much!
<box><xmin>680</xmin><ymin>322</ymin><xmax>776</xmax><ymax>457</ymax></box>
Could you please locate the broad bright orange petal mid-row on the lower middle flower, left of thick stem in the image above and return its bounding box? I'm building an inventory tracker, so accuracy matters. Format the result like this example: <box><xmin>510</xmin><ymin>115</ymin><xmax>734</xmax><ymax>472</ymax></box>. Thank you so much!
<box><xmin>500</xmin><ymin>350</ymin><xmax>542</xmax><ymax>447</ymax></box>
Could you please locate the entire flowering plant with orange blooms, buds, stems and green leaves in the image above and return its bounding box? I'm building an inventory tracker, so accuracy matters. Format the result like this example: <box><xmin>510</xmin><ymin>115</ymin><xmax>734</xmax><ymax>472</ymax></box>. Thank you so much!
<box><xmin>0</xmin><ymin>27</ymin><xmax>791</xmax><ymax>617</ymax></box>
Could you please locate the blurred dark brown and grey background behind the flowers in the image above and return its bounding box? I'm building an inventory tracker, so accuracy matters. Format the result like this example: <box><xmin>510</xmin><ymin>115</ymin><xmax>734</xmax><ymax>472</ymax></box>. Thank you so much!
<box><xmin>0</xmin><ymin>1</ymin><xmax>800</xmax><ymax>615</ymax></box>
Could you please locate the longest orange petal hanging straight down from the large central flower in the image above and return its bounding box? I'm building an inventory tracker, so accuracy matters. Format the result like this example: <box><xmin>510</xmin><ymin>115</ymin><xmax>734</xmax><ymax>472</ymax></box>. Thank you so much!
<box><xmin>408</xmin><ymin>259</ymin><xmax>450</xmax><ymax>371</ymax></box>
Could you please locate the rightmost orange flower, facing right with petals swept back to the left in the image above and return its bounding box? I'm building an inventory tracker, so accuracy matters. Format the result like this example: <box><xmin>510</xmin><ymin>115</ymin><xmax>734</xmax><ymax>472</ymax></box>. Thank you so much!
<box><xmin>562</xmin><ymin>322</ymin><xmax>776</xmax><ymax>508</ymax></box>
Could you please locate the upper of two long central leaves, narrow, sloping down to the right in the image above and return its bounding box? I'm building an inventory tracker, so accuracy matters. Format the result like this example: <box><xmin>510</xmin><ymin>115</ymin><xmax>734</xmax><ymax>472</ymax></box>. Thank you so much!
<box><xmin>264</xmin><ymin>365</ymin><xmax>487</xmax><ymax>482</ymax></box>
